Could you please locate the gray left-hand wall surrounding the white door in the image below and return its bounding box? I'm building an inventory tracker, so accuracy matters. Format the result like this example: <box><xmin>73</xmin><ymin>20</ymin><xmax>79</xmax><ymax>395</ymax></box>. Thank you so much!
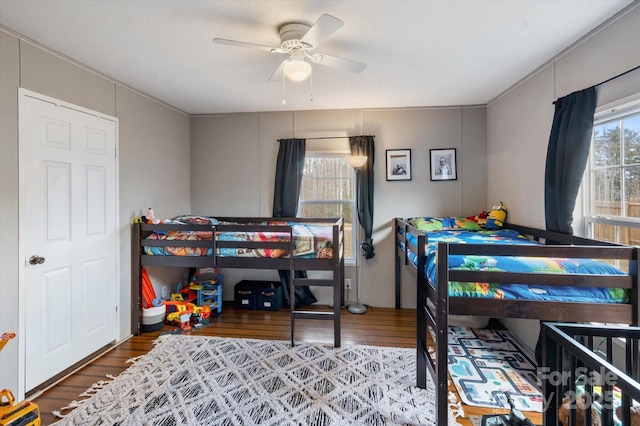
<box><xmin>0</xmin><ymin>29</ymin><xmax>191</xmax><ymax>396</ymax></box>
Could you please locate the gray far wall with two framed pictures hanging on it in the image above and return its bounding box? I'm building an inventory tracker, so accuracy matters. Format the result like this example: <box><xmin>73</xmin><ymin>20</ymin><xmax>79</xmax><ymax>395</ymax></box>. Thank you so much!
<box><xmin>191</xmin><ymin>107</ymin><xmax>487</xmax><ymax>308</ymax></box>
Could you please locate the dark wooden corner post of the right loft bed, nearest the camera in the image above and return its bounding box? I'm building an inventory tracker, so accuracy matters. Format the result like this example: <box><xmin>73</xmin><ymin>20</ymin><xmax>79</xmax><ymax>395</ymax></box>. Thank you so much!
<box><xmin>436</xmin><ymin>243</ymin><xmax>449</xmax><ymax>424</ymax></box>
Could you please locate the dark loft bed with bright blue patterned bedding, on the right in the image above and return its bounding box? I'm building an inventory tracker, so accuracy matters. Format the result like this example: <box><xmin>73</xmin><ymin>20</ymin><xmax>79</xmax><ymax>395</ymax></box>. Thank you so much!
<box><xmin>394</xmin><ymin>218</ymin><xmax>639</xmax><ymax>419</ymax></box>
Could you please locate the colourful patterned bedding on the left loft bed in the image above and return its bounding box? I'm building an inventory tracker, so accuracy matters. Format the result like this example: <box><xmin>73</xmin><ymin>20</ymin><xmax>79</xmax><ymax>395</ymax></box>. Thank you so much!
<box><xmin>144</xmin><ymin>216</ymin><xmax>333</xmax><ymax>259</ymax></box>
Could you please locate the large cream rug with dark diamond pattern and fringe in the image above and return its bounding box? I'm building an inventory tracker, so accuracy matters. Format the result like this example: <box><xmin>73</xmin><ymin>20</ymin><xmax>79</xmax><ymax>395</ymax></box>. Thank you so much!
<box><xmin>55</xmin><ymin>335</ymin><xmax>459</xmax><ymax>426</ymax></box>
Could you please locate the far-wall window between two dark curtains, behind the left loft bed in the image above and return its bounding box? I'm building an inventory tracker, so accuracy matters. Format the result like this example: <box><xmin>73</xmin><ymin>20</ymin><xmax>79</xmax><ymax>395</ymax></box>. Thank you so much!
<box><xmin>298</xmin><ymin>153</ymin><xmax>357</xmax><ymax>261</ymax></box>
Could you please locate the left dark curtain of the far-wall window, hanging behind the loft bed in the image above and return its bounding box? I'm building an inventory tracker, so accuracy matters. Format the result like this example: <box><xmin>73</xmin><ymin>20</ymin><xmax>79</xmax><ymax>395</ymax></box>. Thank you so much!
<box><xmin>273</xmin><ymin>139</ymin><xmax>318</xmax><ymax>306</ymax></box>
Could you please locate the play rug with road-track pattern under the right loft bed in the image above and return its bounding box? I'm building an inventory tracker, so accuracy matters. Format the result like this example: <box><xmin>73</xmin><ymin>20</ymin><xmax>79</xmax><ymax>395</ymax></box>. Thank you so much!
<box><xmin>448</xmin><ymin>327</ymin><xmax>542</xmax><ymax>412</ymax></box>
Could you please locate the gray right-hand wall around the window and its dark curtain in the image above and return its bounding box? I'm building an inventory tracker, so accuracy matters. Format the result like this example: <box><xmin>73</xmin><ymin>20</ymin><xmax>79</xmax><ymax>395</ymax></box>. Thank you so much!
<box><xmin>487</xmin><ymin>8</ymin><xmax>640</xmax><ymax>347</ymax></box>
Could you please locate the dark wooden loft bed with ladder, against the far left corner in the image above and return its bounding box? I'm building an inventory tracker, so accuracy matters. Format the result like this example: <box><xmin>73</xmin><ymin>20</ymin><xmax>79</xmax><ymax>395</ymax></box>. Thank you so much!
<box><xmin>131</xmin><ymin>215</ymin><xmax>344</xmax><ymax>347</ymax></box>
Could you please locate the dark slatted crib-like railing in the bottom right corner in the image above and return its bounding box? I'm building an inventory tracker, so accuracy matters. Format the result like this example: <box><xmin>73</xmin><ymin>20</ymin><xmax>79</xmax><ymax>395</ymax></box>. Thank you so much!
<box><xmin>538</xmin><ymin>322</ymin><xmax>640</xmax><ymax>426</ymax></box>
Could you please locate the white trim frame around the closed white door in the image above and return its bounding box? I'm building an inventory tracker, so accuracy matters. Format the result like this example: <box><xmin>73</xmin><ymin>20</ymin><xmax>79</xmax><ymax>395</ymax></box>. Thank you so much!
<box><xmin>16</xmin><ymin>87</ymin><xmax>122</xmax><ymax>401</ymax></box>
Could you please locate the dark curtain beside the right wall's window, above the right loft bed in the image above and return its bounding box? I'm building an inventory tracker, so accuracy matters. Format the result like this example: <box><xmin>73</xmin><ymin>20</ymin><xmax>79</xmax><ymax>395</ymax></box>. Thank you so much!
<box><xmin>544</xmin><ymin>87</ymin><xmax>596</xmax><ymax>234</ymax></box>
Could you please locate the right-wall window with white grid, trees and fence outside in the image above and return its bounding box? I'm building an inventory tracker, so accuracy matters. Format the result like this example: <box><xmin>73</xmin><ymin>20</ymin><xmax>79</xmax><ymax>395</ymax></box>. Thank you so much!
<box><xmin>586</xmin><ymin>101</ymin><xmax>640</xmax><ymax>245</ymax></box>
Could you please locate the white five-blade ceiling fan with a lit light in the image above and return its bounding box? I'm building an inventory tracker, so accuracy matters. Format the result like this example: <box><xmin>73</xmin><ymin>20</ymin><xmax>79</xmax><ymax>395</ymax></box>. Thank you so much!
<box><xmin>213</xmin><ymin>14</ymin><xmax>367</xmax><ymax>81</ymax></box>
